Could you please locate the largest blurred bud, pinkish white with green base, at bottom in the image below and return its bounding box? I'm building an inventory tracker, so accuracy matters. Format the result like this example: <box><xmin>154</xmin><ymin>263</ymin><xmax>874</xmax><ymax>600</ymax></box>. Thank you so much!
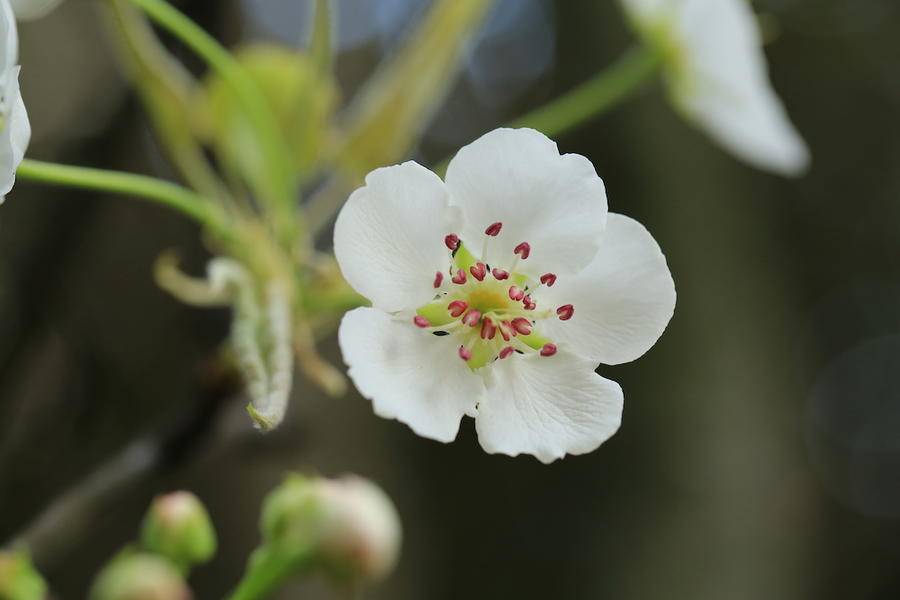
<box><xmin>262</xmin><ymin>475</ymin><xmax>401</xmax><ymax>580</ymax></box>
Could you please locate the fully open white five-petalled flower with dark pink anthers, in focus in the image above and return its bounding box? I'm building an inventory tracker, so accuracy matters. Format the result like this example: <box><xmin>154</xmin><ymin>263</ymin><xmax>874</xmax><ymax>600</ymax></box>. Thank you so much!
<box><xmin>334</xmin><ymin>129</ymin><xmax>675</xmax><ymax>462</ymax></box>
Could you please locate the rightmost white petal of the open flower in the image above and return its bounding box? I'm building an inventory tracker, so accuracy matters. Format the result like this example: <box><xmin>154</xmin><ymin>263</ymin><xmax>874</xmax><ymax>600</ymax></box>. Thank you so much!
<box><xmin>536</xmin><ymin>213</ymin><xmax>675</xmax><ymax>365</ymax></box>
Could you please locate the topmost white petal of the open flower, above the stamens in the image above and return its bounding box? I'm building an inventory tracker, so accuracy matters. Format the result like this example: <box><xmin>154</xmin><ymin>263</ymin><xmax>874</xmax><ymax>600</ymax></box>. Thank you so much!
<box><xmin>446</xmin><ymin>129</ymin><xmax>606</xmax><ymax>275</ymax></box>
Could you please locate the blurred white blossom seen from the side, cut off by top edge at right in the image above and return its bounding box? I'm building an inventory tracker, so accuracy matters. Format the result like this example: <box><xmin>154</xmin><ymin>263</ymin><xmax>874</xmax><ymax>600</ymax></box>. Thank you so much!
<box><xmin>621</xmin><ymin>0</ymin><xmax>809</xmax><ymax>175</ymax></box>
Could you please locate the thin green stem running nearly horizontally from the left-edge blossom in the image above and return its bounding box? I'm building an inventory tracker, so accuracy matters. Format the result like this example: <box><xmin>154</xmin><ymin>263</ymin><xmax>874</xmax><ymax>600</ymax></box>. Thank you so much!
<box><xmin>16</xmin><ymin>159</ymin><xmax>227</xmax><ymax>233</ymax></box>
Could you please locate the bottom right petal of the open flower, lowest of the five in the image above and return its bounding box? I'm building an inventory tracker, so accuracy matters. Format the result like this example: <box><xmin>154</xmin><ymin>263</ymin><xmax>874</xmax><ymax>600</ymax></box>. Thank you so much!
<box><xmin>475</xmin><ymin>352</ymin><xmax>623</xmax><ymax>463</ymax></box>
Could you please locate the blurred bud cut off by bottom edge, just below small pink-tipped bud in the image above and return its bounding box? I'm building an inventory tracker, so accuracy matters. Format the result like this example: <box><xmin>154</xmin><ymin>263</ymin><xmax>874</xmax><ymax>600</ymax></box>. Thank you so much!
<box><xmin>90</xmin><ymin>551</ymin><xmax>191</xmax><ymax>600</ymax></box>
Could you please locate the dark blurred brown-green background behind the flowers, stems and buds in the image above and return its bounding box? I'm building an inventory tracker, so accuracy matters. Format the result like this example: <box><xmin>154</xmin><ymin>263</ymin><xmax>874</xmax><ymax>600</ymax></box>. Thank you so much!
<box><xmin>0</xmin><ymin>0</ymin><xmax>900</xmax><ymax>600</ymax></box>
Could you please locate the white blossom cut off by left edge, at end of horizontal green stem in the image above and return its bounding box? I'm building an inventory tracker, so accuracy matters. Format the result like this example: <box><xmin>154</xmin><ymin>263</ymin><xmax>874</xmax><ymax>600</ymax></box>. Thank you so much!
<box><xmin>0</xmin><ymin>0</ymin><xmax>31</xmax><ymax>203</ymax></box>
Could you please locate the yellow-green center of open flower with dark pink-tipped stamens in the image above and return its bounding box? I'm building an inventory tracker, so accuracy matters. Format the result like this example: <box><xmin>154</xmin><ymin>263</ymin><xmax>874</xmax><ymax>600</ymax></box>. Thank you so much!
<box><xmin>413</xmin><ymin>222</ymin><xmax>575</xmax><ymax>370</ymax></box>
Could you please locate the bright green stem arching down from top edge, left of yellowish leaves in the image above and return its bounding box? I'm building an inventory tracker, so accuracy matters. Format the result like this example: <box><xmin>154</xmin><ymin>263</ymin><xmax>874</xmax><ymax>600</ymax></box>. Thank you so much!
<box><xmin>130</xmin><ymin>0</ymin><xmax>297</xmax><ymax>234</ymax></box>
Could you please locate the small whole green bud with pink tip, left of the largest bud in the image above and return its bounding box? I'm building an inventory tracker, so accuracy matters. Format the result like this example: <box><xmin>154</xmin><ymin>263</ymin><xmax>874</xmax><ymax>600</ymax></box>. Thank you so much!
<box><xmin>141</xmin><ymin>492</ymin><xmax>216</xmax><ymax>572</ymax></box>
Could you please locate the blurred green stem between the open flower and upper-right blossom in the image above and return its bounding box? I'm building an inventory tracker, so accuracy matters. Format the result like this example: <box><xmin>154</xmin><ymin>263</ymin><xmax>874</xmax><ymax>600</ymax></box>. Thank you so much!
<box><xmin>509</xmin><ymin>46</ymin><xmax>660</xmax><ymax>136</ymax></box>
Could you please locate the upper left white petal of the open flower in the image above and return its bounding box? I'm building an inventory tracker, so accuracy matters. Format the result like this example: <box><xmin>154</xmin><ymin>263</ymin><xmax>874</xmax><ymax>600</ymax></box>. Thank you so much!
<box><xmin>334</xmin><ymin>162</ymin><xmax>459</xmax><ymax>312</ymax></box>
